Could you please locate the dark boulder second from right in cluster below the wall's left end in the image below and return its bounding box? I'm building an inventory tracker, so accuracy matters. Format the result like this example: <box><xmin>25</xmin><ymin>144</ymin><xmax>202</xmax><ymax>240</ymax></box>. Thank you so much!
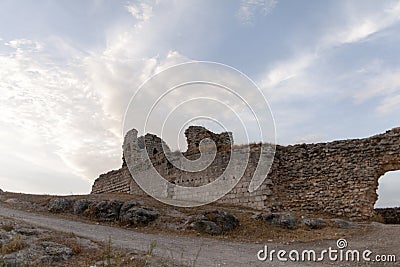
<box><xmin>85</xmin><ymin>200</ymin><xmax>123</xmax><ymax>221</ymax></box>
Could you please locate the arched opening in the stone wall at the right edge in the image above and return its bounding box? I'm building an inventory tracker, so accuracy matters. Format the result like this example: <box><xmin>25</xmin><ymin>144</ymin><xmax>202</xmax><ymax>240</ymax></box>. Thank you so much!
<box><xmin>374</xmin><ymin>171</ymin><xmax>400</xmax><ymax>224</ymax></box>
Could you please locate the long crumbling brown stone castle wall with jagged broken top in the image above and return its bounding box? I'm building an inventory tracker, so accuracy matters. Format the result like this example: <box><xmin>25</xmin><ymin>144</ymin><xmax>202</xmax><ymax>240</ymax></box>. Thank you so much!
<box><xmin>92</xmin><ymin>126</ymin><xmax>400</xmax><ymax>220</ymax></box>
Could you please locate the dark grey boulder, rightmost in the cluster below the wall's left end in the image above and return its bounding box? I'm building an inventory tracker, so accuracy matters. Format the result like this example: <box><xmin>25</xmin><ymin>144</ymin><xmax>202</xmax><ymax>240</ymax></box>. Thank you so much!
<box><xmin>120</xmin><ymin>207</ymin><xmax>160</xmax><ymax>225</ymax></box>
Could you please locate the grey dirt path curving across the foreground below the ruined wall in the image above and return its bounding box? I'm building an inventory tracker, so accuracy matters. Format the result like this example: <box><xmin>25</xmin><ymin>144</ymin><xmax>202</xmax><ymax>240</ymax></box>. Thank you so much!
<box><xmin>0</xmin><ymin>205</ymin><xmax>400</xmax><ymax>266</ymax></box>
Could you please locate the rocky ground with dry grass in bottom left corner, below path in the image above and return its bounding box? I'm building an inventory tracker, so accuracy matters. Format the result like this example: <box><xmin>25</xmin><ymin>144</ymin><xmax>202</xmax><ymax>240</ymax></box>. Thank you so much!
<box><xmin>0</xmin><ymin>217</ymin><xmax>101</xmax><ymax>267</ymax></box>
